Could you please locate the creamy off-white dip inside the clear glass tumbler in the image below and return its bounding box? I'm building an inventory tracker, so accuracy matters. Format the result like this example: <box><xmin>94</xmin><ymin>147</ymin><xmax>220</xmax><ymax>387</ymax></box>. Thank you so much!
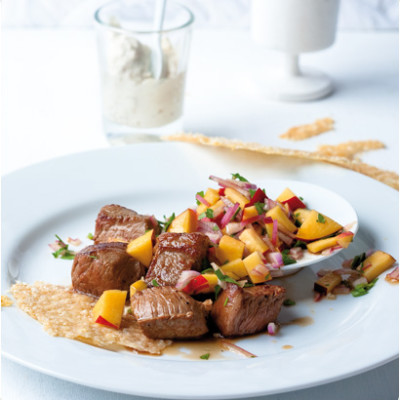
<box><xmin>103</xmin><ymin>26</ymin><xmax>185</xmax><ymax>128</ymax></box>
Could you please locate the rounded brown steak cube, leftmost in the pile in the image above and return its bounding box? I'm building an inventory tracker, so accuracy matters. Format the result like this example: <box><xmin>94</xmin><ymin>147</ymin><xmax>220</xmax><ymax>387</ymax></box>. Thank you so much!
<box><xmin>71</xmin><ymin>242</ymin><xmax>145</xmax><ymax>296</ymax></box>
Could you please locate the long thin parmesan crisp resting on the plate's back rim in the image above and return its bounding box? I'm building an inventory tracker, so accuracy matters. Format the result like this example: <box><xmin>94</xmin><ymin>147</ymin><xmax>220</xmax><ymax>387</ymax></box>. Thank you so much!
<box><xmin>162</xmin><ymin>132</ymin><xmax>399</xmax><ymax>190</ymax></box>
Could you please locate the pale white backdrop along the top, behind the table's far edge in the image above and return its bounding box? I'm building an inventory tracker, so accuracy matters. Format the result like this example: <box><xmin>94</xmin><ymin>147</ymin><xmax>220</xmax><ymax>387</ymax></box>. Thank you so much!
<box><xmin>3</xmin><ymin>0</ymin><xmax>399</xmax><ymax>29</ymax></box>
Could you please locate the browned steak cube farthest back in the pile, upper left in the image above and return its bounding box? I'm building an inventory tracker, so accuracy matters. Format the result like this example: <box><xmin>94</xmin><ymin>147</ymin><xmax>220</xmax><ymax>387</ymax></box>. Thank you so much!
<box><xmin>93</xmin><ymin>204</ymin><xmax>159</xmax><ymax>243</ymax></box>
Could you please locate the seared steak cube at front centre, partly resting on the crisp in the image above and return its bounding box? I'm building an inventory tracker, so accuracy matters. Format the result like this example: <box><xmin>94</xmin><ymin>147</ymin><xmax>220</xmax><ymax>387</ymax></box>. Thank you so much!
<box><xmin>131</xmin><ymin>286</ymin><xmax>212</xmax><ymax>339</ymax></box>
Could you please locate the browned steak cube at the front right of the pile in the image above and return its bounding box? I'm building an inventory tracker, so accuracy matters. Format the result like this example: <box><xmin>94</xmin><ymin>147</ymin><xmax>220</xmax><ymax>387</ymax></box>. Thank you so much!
<box><xmin>211</xmin><ymin>283</ymin><xmax>285</xmax><ymax>337</ymax></box>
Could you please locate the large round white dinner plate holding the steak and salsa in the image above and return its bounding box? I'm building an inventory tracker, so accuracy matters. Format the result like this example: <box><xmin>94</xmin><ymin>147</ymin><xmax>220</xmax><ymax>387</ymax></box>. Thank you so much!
<box><xmin>2</xmin><ymin>143</ymin><xmax>398</xmax><ymax>399</ymax></box>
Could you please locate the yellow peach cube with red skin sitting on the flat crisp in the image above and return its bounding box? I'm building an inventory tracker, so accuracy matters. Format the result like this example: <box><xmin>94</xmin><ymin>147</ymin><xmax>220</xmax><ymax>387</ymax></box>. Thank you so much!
<box><xmin>92</xmin><ymin>290</ymin><xmax>127</xmax><ymax>329</ymax></box>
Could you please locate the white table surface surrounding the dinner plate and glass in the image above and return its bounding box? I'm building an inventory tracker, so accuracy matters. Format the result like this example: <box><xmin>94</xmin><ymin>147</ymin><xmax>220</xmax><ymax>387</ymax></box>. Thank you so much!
<box><xmin>1</xmin><ymin>29</ymin><xmax>399</xmax><ymax>400</ymax></box>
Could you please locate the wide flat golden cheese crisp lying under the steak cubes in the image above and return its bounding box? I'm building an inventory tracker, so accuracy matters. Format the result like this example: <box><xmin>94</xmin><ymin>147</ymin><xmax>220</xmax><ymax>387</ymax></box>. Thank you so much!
<box><xmin>11</xmin><ymin>282</ymin><xmax>172</xmax><ymax>354</ymax></box>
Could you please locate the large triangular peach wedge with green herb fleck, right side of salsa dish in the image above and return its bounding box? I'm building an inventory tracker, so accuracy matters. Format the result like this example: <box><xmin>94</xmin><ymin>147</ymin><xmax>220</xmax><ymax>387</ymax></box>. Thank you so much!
<box><xmin>297</xmin><ymin>210</ymin><xmax>342</xmax><ymax>240</ymax></box>
